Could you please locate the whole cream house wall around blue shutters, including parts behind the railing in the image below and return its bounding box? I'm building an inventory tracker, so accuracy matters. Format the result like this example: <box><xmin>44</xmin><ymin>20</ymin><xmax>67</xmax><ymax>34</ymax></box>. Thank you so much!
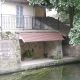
<box><xmin>0</xmin><ymin>0</ymin><xmax>35</xmax><ymax>30</ymax></box>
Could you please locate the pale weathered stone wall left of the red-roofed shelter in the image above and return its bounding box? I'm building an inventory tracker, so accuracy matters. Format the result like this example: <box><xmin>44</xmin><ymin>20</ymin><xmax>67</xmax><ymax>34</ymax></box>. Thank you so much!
<box><xmin>0</xmin><ymin>32</ymin><xmax>21</xmax><ymax>73</ymax></box>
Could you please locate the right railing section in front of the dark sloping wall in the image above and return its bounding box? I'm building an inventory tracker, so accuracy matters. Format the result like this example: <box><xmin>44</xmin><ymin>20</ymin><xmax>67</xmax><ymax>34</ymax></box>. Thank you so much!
<box><xmin>32</xmin><ymin>17</ymin><xmax>59</xmax><ymax>30</ymax></box>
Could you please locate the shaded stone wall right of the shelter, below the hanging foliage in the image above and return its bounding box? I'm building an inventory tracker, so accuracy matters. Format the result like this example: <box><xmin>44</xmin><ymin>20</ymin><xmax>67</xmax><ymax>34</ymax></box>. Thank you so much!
<box><xmin>62</xmin><ymin>38</ymin><xmax>80</xmax><ymax>57</ymax></box>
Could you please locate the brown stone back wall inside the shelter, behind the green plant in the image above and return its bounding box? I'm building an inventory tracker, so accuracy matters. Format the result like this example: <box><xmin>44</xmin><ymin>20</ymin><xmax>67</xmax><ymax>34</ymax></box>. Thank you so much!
<box><xmin>20</xmin><ymin>40</ymin><xmax>44</xmax><ymax>59</ymax></box>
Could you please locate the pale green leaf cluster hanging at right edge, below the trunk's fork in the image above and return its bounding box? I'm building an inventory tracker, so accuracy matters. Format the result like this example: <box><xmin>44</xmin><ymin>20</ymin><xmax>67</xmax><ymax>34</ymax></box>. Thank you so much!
<box><xmin>69</xmin><ymin>14</ymin><xmax>80</xmax><ymax>46</ymax></box>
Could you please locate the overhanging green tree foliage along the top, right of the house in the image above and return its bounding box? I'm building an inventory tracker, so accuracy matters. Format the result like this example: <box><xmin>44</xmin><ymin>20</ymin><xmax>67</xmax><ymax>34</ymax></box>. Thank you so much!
<box><xmin>29</xmin><ymin>0</ymin><xmax>80</xmax><ymax>20</ymax></box>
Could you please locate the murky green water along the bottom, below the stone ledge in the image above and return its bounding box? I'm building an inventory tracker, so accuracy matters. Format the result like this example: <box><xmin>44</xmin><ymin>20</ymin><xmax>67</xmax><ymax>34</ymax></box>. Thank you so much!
<box><xmin>0</xmin><ymin>64</ymin><xmax>80</xmax><ymax>80</ymax></box>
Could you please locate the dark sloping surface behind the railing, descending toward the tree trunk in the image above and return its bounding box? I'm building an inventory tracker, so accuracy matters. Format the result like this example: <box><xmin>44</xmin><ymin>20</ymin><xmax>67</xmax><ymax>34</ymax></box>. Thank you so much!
<box><xmin>36</xmin><ymin>17</ymin><xmax>70</xmax><ymax>36</ymax></box>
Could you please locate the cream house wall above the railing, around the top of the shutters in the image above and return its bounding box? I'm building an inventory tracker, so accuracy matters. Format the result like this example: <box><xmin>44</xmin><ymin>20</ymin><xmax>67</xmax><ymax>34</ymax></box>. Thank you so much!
<box><xmin>2</xmin><ymin>2</ymin><xmax>34</xmax><ymax>16</ymax></box>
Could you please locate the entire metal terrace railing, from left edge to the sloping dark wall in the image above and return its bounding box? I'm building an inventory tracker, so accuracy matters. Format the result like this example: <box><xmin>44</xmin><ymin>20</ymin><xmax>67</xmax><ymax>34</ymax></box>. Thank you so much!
<box><xmin>0</xmin><ymin>15</ymin><xmax>59</xmax><ymax>30</ymax></box>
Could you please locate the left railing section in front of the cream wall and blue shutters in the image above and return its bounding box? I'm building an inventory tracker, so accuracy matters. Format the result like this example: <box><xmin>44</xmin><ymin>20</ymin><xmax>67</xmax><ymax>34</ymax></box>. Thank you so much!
<box><xmin>2</xmin><ymin>15</ymin><xmax>32</xmax><ymax>30</ymax></box>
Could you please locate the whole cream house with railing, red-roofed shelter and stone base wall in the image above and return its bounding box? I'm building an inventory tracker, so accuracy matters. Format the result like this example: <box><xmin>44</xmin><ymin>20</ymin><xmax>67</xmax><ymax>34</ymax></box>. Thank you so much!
<box><xmin>0</xmin><ymin>0</ymin><xmax>63</xmax><ymax>73</ymax></box>
